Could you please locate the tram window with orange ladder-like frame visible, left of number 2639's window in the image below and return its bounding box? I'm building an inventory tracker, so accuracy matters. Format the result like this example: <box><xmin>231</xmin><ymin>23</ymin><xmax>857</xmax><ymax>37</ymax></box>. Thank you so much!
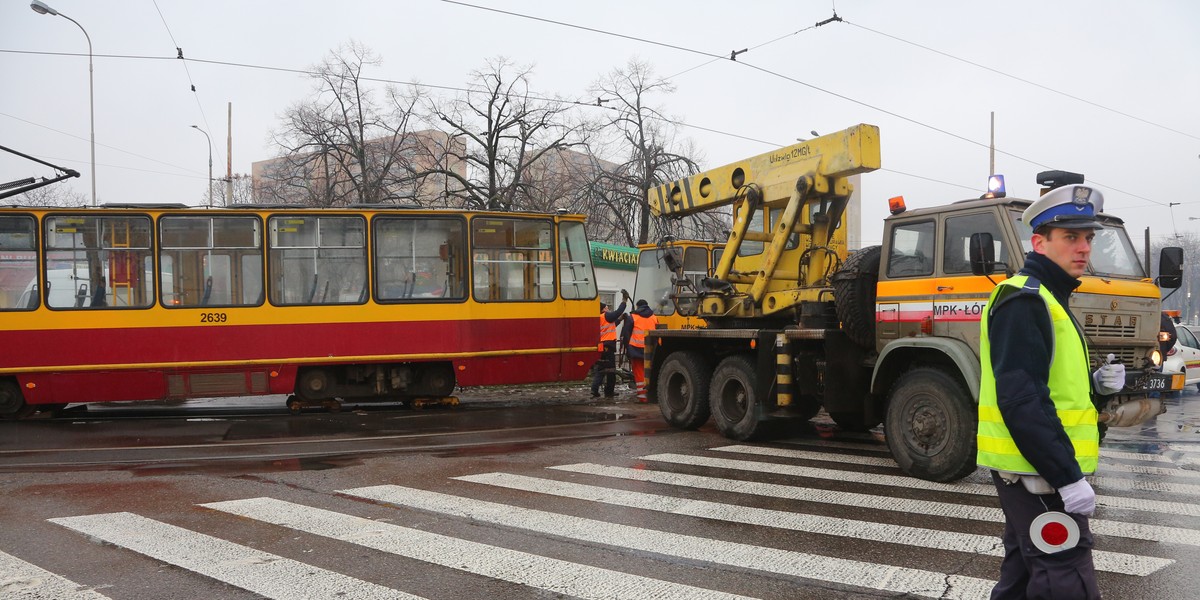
<box><xmin>43</xmin><ymin>215</ymin><xmax>155</xmax><ymax>308</ymax></box>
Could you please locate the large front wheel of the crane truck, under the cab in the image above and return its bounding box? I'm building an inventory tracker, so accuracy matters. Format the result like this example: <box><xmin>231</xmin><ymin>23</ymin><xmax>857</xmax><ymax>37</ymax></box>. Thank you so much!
<box><xmin>884</xmin><ymin>367</ymin><xmax>977</xmax><ymax>481</ymax></box>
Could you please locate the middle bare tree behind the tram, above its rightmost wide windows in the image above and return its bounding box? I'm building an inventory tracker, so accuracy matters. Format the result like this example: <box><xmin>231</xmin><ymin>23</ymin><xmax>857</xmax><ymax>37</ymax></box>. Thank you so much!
<box><xmin>425</xmin><ymin>58</ymin><xmax>586</xmax><ymax>210</ymax></box>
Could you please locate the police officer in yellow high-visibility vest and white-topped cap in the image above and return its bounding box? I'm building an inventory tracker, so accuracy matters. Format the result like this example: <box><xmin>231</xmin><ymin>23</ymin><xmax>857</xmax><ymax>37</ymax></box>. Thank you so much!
<box><xmin>977</xmin><ymin>185</ymin><xmax>1124</xmax><ymax>600</ymax></box>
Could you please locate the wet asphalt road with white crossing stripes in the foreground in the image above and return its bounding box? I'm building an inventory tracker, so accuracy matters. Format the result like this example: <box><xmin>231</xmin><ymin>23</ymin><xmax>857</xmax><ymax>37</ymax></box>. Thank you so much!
<box><xmin>0</xmin><ymin>386</ymin><xmax>1200</xmax><ymax>599</ymax></box>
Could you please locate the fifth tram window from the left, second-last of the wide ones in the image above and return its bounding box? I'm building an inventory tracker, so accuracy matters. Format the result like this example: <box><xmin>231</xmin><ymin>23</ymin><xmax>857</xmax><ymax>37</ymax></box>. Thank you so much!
<box><xmin>372</xmin><ymin>217</ymin><xmax>467</xmax><ymax>301</ymax></box>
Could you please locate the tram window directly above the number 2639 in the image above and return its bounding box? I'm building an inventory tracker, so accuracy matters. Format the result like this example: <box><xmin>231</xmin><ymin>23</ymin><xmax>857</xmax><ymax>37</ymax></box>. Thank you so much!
<box><xmin>158</xmin><ymin>215</ymin><xmax>263</xmax><ymax>307</ymax></box>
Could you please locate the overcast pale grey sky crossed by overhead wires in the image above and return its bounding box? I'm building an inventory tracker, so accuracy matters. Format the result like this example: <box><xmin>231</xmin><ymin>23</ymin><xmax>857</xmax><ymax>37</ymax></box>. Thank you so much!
<box><xmin>0</xmin><ymin>0</ymin><xmax>1200</xmax><ymax>244</ymax></box>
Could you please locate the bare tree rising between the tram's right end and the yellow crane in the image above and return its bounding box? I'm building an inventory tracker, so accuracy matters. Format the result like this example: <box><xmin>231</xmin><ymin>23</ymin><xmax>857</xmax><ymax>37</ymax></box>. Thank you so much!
<box><xmin>586</xmin><ymin>60</ymin><xmax>728</xmax><ymax>246</ymax></box>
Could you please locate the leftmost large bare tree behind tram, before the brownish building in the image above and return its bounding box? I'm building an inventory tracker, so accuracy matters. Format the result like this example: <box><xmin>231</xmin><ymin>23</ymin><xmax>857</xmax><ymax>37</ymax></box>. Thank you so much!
<box><xmin>256</xmin><ymin>42</ymin><xmax>422</xmax><ymax>206</ymax></box>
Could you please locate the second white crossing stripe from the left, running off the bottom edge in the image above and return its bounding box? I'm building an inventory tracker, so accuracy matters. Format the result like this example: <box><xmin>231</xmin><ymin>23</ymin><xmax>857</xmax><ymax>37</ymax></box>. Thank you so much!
<box><xmin>49</xmin><ymin>512</ymin><xmax>419</xmax><ymax>600</ymax></box>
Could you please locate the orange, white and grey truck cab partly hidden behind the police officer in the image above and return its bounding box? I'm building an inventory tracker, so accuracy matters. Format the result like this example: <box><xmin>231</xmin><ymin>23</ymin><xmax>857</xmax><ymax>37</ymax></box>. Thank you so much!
<box><xmin>864</xmin><ymin>192</ymin><xmax>1183</xmax><ymax>473</ymax></box>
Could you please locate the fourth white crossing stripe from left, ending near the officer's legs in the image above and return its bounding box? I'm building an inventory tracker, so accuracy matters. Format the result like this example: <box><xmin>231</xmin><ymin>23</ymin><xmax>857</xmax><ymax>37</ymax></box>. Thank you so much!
<box><xmin>341</xmin><ymin>478</ymin><xmax>995</xmax><ymax>598</ymax></box>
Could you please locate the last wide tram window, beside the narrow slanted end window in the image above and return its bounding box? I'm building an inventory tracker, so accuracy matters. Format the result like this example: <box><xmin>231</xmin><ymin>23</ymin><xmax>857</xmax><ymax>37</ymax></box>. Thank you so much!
<box><xmin>472</xmin><ymin>217</ymin><xmax>556</xmax><ymax>301</ymax></box>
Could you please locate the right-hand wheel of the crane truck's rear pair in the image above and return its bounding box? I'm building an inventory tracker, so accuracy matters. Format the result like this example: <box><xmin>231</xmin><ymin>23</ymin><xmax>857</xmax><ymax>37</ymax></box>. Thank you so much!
<box><xmin>708</xmin><ymin>355</ymin><xmax>769</xmax><ymax>442</ymax></box>
